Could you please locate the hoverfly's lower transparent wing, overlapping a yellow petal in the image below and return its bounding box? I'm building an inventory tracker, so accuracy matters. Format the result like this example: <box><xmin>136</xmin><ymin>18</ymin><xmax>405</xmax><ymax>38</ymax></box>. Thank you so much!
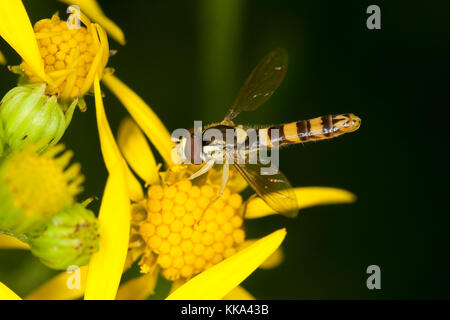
<box><xmin>234</xmin><ymin>164</ymin><xmax>298</xmax><ymax>218</ymax></box>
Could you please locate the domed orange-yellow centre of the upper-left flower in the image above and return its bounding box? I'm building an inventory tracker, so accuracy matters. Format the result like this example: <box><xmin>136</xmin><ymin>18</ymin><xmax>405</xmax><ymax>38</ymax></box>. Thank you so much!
<box><xmin>20</xmin><ymin>14</ymin><xmax>109</xmax><ymax>100</ymax></box>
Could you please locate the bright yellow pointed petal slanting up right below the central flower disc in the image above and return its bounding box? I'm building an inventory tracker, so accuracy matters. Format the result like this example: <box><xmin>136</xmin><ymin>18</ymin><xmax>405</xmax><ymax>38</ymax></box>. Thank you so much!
<box><xmin>167</xmin><ymin>229</ymin><xmax>286</xmax><ymax>300</ymax></box>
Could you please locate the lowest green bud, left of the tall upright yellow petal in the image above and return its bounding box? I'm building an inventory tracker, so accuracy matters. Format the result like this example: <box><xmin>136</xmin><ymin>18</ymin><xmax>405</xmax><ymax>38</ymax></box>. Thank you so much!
<box><xmin>27</xmin><ymin>203</ymin><xmax>99</xmax><ymax>270</ymax></box>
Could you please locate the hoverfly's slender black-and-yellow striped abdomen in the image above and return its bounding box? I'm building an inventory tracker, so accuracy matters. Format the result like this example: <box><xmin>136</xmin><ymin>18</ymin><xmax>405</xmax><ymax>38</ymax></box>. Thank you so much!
<box><xmin>259</xmin><ymin>113</ymin><xmax>361</xmax><ymax>147</ymax></box>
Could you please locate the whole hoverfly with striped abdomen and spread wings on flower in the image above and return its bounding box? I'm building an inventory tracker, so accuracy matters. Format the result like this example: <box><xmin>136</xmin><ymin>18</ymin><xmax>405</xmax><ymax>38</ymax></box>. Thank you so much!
<box><xmin>175</xmin><ymin>49</ymin><xmax>361</xmax><ymax>217</ymax></box>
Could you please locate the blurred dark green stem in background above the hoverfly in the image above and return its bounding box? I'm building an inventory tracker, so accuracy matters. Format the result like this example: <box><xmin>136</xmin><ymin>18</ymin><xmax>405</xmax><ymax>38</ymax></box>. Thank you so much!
<box><xmin>199</xmin><ymin>0</ymin><xmax>244</xmax><ymax>121</ymax></box>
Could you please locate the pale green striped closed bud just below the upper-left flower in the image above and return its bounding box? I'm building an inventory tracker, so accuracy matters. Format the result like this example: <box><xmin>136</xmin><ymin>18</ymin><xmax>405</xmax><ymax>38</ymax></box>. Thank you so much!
<box><xmin>0</xmin><ymin>83</ymin><xmax>78</xmax><ymax>151</ymax></box>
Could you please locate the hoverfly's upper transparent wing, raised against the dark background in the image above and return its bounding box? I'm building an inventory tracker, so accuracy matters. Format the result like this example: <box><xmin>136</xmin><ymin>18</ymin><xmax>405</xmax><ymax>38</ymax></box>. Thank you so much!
<box><xmin>225</xmin><ymin>48</ymin><xmax>288</xmax><ymax>121</ymax></box>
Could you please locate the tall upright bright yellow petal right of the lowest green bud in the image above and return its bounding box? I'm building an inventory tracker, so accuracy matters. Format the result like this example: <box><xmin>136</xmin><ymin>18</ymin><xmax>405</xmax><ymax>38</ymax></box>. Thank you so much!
<box><xmin>84</xmin><ymin>163</ymin><xmax>130</xmax><ymax>300</ymax></box>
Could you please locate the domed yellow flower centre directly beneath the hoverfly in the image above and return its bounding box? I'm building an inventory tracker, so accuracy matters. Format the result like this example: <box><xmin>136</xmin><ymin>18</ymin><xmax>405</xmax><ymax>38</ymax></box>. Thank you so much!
<box><xmin>137</xmin><ymin>179</ymin><xmax>245</xmax><ymax>281</ymax></box>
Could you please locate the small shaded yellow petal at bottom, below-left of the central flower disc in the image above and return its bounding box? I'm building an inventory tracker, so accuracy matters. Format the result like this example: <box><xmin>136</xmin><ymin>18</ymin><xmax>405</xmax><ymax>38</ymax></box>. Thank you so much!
<box><xmin>116</xmin><ymin>268</ymin><xmax>159</xmax><ymax>300</ymax></box>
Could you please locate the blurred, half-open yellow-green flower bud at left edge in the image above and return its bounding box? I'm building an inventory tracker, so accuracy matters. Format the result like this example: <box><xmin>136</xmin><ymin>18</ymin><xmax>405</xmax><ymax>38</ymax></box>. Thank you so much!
<box><xmin>0</xmin><ymin>145</ymin><xmax>84</xmax><ymax>234</ymax></box>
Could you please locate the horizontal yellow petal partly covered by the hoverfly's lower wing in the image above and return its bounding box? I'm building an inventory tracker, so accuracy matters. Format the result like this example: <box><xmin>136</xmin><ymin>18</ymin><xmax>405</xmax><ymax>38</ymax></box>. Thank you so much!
<box><xmin>245</xmin><ymin>187</ymin><xmax>356</xmax><ymax>219</ymax></box>
